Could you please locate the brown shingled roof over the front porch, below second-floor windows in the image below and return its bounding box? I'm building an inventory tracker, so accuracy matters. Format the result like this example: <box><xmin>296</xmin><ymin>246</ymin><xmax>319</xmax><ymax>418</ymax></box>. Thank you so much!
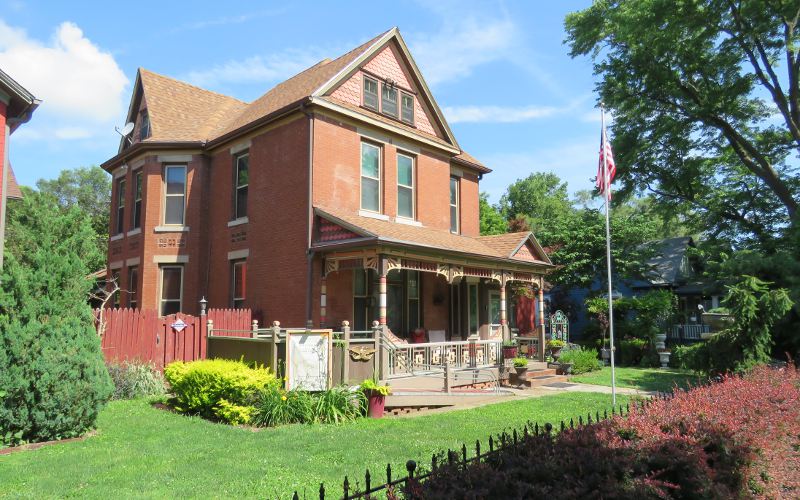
<box><xmin>315</xmin><ymin>207</ymin><xmax>545</xmax><ymax>264</ymax></box>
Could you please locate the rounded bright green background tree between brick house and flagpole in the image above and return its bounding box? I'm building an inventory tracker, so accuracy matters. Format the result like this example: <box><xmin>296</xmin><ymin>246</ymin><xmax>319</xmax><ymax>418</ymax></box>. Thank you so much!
<box><xmin>500</xmin><ymin>172</ymin><xmax>572</xmax><ymax>235</ymax></box>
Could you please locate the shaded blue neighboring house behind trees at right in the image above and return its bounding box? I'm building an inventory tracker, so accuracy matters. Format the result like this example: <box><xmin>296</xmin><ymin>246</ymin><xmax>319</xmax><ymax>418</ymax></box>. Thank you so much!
<box><xmin>545</xmin><ymin>236</ymin><xmax>721</xmax><ymax>340</ymax></box>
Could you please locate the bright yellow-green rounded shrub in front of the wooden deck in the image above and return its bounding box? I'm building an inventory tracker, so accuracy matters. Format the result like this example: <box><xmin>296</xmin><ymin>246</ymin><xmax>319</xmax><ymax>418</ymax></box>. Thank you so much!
<box><xmin>164</xmin><ymin>359</ymin><xmax>277</xmax><ymax>418</ymax></box>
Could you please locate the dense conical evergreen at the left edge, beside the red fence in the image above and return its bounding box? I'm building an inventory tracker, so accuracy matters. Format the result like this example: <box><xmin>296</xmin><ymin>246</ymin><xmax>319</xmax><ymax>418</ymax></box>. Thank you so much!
<box><xmin>0</xmin><ymin>189</ymin><xmax>112</xmax><ymax>445</ymax></box>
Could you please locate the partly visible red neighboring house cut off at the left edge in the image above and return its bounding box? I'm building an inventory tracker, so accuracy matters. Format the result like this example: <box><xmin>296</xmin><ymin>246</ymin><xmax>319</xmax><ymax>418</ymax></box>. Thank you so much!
<box><xmin>0</xmin><ymin>70</ymin><xmax>39</xmax><ymax>268</ymax></box>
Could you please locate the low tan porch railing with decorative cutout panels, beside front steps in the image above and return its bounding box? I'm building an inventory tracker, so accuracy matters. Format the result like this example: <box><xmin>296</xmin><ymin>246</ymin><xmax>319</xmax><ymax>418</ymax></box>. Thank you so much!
<box><xmin>387</xmin><ymin>340</ymin><xmax>503</xmax><ymax>377</ymax></box>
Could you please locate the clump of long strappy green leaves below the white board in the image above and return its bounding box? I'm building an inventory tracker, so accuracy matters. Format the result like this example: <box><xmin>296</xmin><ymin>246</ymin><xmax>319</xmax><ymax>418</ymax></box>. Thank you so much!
<box><xmin>251</xmin><ymin>387</ymin><xmax>366</xmax><ymax>427</ymax></box>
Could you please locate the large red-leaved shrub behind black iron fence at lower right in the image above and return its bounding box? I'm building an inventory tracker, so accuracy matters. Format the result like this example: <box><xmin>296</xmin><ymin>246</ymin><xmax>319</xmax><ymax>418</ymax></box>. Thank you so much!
<box><xmin>403</xmin><ymin>367</ymin><xmax>800</xmax><ymax>499</ymax></box>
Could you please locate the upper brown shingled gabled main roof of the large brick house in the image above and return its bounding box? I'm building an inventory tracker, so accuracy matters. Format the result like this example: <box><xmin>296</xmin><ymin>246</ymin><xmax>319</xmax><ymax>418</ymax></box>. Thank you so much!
<box><xmin>109</xmin><ymin>28</ymin><xmax>491</xmax><ymax>173</ymax></box>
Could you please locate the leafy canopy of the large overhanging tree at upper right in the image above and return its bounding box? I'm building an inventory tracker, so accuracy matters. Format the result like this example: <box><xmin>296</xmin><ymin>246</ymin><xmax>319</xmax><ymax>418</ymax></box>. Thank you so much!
<box><xmin>566</xmin><ymin>0</ymin><xmax>800</xmax><ymax>249</ymax></box>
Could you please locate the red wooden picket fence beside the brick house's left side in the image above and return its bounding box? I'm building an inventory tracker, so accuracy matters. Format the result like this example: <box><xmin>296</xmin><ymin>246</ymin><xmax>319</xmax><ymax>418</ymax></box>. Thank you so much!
<box><xmin>95</xmin><ymin>309</ymin><xmax>252</xmax><ymax>370</ymax></box>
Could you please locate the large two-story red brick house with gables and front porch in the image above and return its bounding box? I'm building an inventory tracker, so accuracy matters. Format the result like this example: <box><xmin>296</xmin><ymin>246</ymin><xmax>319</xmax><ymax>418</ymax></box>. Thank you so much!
<box><xmin>103</xmin><ymin>29</ymin><xmax>552</xmax><ymax>339</ymax></box>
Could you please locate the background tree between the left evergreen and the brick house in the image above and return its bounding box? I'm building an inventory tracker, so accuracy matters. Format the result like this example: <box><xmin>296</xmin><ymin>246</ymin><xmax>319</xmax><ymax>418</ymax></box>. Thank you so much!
<box><xmin>36</xmin><ymin>166</ymin><xmax>111</xmax><ymax>243</ymax></box>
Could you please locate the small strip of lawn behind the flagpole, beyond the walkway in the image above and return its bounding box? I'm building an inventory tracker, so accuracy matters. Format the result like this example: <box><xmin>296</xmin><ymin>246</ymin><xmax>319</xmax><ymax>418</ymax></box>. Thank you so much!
<box><xmin>571</xmin><ymin>366</ymin><xmax>702</xmax><ymax>392</ymax></box>
